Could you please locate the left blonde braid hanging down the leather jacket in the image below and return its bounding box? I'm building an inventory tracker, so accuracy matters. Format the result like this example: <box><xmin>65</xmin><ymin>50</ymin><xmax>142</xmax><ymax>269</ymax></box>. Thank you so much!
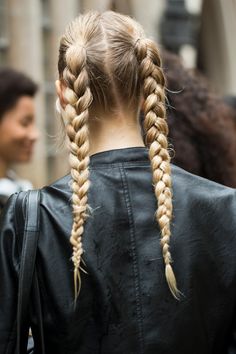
<box><xmin>63</xmin><ymin>44</ymin><xmax>92</xmax><ymax>299</ymax></box>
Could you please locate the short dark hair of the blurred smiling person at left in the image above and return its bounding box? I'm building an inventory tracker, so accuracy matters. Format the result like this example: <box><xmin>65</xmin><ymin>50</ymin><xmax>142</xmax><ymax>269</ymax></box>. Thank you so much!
<box><xmin>0</xmin><ymin>68</ymin><xmax>38</xmax><ymax>120</ymax></box>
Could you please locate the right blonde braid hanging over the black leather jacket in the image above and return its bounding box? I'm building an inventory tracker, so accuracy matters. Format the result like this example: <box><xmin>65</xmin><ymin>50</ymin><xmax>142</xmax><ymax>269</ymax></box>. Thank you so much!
<box><xmin>135</xmin><ymin>39</ymin><xmax>180</xmax><ymax>299</ymax></box>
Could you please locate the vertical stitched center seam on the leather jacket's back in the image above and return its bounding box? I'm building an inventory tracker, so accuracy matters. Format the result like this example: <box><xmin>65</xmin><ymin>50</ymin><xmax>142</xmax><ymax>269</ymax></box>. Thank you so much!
<box><xmin>120</xmin><ymin>166</ymin><xmax>144</xmax><ymax>354</ymax></box>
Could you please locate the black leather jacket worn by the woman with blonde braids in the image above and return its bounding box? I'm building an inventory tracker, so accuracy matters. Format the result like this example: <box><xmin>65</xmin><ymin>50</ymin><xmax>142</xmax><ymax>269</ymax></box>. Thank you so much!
<box><xmin>0</xmin><ymin>148</ymin><xmax>236</xmax><ymax>354</ymax></box>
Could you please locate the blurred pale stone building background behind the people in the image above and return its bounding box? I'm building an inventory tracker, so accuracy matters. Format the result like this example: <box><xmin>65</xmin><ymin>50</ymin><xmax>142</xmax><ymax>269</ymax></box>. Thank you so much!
<box><xmin>0</xmin><ymin>0</ymin><xmax>236</xmax><ymax>187</ymax></box>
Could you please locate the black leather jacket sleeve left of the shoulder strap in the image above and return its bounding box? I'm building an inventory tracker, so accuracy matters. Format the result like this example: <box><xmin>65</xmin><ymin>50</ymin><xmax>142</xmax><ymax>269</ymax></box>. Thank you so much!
<box><xmin>0</xmin><ymin>194</ymin><xmax>19</xmax><ymax>354</ymax></box>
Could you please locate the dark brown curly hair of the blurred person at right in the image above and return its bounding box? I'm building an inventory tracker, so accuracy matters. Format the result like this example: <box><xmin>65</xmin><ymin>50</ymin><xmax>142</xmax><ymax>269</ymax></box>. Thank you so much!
<box><xmin>162</xmin><ymin>51</ymin><xmax>236</xmax><ymax>187</ymax></box>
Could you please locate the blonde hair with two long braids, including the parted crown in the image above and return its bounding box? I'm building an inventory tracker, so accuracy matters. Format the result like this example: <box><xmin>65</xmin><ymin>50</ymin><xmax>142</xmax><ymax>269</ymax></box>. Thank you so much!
<box><xmin>58</xmin><ymin>11</ymin><xmax>179</xmax><ymax>298</ymax></box>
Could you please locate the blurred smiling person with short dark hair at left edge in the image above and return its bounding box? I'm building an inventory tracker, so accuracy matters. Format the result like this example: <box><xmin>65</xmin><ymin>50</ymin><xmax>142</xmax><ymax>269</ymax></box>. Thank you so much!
<box><xmin>0</xmin><ymin>68</ymin><xmax>38</xmax><ymax>208</ymax></box>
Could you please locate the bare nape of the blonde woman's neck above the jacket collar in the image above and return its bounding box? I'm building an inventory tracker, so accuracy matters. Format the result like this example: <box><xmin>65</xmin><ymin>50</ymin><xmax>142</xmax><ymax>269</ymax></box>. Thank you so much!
<box><xmin>89</xmin><ymin>110</ymin><xmax>144</xmax><ymax>155</ymax></box>
